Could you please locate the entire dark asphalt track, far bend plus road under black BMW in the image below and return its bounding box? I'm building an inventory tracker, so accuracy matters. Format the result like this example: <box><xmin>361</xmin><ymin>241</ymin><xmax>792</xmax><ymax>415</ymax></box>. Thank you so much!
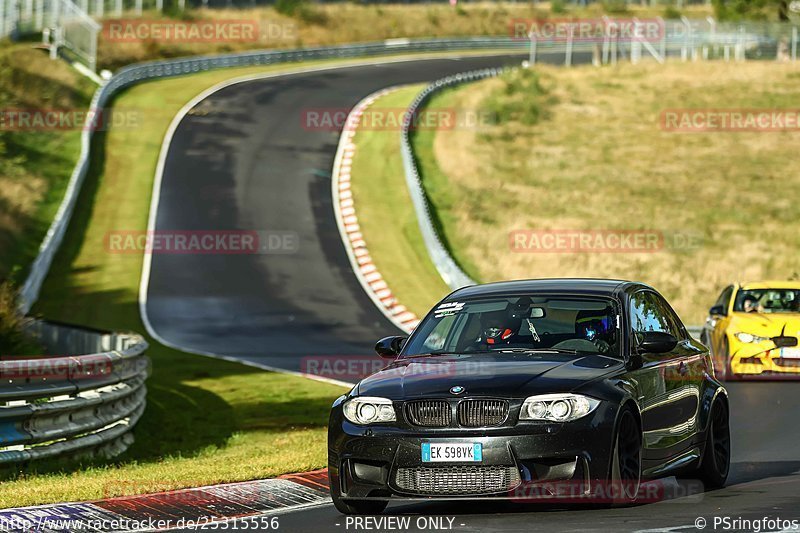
<box><xmin>146</xmin><ymin>51</ymin><xmax>800</xmax><ymax>533</ymax></box>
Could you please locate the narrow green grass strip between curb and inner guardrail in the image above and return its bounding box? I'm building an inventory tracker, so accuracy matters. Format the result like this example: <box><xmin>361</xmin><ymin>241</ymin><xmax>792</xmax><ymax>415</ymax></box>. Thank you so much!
<box><xmin>351</xmin><ymin>85</ymin><xmax>450</xmax><ymax>318</ymax></box>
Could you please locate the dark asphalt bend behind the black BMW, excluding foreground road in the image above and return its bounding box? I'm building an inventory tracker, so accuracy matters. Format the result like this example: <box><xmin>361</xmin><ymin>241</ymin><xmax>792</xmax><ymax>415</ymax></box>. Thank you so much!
<box><xmin>145</xmin><ymin>55</ymin><xmax>548</xmax><ymax>381</ymax></box>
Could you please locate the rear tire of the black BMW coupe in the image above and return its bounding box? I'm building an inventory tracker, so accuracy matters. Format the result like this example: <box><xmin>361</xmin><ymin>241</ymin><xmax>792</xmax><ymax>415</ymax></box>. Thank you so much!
<box><xmin>695</xmin><ymin>400</ymin><xmax>731</xmax><ymax>490</ymax></box>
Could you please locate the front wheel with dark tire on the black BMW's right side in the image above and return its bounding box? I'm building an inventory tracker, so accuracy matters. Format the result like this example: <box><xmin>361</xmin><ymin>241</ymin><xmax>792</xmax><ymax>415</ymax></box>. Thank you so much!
<box><xmin>608</xmin><ymin>407</ymin><xmax>642</xmax><ymax>506</ymax></box>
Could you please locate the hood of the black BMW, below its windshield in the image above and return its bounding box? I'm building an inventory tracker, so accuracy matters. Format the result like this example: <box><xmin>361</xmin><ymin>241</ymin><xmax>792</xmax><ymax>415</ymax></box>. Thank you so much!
<box><xmin>356</xmin><ymin>354</ymin><xmax>623</xmax><ymax>400</ymax></box>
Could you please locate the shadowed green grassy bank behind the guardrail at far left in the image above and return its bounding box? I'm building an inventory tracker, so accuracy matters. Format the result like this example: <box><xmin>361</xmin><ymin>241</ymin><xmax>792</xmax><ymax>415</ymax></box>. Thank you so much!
<box><xmin>0</xmin><ymin>44</ymin><xmax>95</xmax><ymax>284</ymax></box>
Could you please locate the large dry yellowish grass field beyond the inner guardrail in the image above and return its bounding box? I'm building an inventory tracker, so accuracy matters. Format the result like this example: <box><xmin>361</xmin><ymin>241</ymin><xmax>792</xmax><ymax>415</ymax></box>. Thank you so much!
<box><xmin>415</xmin><ymin>62</ymin><xmax>800</xmax><ymax>323</ymax></box>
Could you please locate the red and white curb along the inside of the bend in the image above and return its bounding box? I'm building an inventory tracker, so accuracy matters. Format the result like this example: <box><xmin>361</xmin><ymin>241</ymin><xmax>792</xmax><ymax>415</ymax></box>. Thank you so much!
<box><xmin>331</xmin><ymin>87</ymin><xmax>419</xmax><ymax>333</ymax></box>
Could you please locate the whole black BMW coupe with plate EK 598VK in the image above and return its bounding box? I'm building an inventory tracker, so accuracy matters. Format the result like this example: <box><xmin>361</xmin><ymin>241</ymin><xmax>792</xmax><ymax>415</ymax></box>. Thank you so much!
<box><xmin>328</xmin><ymin>279</ymin><xmax>730</xmax><ymax>514</ymax></box>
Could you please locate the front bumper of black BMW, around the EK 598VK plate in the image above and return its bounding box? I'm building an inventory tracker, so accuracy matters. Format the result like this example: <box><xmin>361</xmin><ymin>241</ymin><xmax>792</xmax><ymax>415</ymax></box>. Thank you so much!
<box><xmin>328</xmin><ymin>402</ymin><xmax>617</xmax><ymax>500</ymax></box>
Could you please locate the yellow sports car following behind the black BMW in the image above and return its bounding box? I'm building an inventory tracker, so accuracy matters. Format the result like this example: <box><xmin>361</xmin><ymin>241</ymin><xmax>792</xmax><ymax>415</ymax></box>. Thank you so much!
<box><xmin>700</xmin><ymin>281</ymin><xmax>800</xmax><ymax>380</ymax></box>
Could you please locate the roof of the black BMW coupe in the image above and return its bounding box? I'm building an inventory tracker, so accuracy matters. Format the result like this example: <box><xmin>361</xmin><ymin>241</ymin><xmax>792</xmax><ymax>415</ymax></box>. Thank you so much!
<box><xmin>446</xmin><ymin>278</ymin><xmax>646</xmax><ymax>300</ymax></box>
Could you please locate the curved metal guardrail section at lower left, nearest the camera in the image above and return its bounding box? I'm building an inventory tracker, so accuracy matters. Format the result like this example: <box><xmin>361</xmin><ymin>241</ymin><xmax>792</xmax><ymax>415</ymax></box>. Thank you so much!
<box><xmin>0</xmin><ymin>321</ymin><xmax>150</xmax><ymax>466</ymax></box>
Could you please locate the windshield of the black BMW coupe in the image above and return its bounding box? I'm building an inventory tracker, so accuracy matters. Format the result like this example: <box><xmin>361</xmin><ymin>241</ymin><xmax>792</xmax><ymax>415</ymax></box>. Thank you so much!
<box><xmin>403</xmin><ymin>295</ymin><xmax>620</xmax><ymax>357</ymax></box>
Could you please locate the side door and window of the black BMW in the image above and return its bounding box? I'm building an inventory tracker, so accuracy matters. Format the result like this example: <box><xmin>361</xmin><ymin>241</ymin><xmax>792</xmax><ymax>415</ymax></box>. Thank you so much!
<box><xmin>629</xmin><ymin>289</ymin><xmax>698</xmax><ymax>464</ymax></box>
